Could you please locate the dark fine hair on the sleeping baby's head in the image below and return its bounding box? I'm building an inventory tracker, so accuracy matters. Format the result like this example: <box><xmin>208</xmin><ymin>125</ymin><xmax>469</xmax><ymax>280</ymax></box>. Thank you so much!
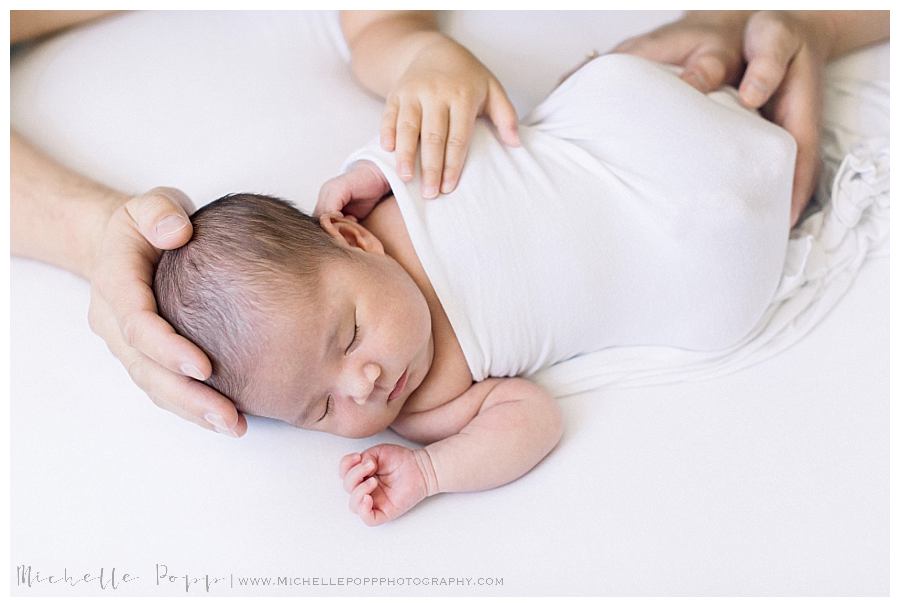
<box><xmin>153</xmin><ymin>194</ymin><xmax>350</xmax><ymax>411</ymax></box>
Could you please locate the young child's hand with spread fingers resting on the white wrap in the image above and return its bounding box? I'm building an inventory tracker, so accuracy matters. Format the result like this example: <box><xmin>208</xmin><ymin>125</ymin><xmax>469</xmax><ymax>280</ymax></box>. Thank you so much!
<box><xmin>381</xmin><ymin>38</ymin><xmax>519</xmax><ymax>198</ymax></box>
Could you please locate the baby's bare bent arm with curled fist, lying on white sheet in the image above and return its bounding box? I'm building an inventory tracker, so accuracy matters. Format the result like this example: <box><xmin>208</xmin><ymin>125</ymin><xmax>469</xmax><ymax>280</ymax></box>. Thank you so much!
<box><xmin>341</xmin><ymin>377</ymin><xmax>562</xmax><ymax>525</ymax></box>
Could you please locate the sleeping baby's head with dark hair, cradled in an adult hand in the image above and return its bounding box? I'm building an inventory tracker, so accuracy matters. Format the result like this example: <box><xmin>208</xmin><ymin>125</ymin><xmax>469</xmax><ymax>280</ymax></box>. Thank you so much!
<box><xmin>153</xmin><ymin>194</ymin><xmax>433</xmax><ymax>437</ymax></box>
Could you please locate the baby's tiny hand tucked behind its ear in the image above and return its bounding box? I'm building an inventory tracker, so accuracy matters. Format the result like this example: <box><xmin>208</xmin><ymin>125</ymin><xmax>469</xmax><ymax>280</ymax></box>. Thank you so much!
<box><xmin>313</xmin><ymin>160</ymin><xmax>391</xmax><ymax>221</ymax></box>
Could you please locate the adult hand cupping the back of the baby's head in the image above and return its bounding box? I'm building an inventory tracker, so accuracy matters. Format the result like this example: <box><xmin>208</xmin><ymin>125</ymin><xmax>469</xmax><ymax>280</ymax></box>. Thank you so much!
<box><xmin>88</xmin><ymin>188</ymin><xmax>247</xmax><ymax>436</ymax></box>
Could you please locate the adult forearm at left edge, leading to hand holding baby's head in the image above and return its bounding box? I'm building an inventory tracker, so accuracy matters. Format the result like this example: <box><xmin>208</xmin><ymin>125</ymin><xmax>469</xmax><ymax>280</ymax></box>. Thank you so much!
<box><xmin>10</xmin><ymin>131</ymin><xmax>129</xmax><ymax>278</ymax></box>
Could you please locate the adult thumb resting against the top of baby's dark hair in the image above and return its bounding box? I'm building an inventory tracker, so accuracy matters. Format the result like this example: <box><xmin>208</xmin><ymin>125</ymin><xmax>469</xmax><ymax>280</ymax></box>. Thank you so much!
<box><xmin>125</xmin><ymin>187</ymin><xmax>194</xmax><ymax>249</ymax></box>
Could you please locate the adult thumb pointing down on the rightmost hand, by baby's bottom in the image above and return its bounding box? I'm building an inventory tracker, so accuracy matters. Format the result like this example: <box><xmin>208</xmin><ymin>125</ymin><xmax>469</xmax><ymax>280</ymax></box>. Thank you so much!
<box><xmin>738</xmin><ymin>11</ymin><xmax>800</xmax><ymax>108</ymax></box>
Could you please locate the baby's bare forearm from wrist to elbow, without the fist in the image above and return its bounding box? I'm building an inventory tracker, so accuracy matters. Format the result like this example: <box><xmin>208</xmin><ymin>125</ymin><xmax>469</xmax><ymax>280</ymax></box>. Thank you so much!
<box><xmin>419</xmin><ymin>397</ymin><xmax>562</xmax><ymax>495</ymax></box>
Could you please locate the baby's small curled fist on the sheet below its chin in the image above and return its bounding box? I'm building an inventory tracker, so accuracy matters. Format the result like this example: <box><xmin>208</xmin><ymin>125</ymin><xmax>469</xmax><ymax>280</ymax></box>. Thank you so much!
<box><xmin>340</xmin><ymin>443</ymin><xmax>428</xmax><ymax>526</ymax></box>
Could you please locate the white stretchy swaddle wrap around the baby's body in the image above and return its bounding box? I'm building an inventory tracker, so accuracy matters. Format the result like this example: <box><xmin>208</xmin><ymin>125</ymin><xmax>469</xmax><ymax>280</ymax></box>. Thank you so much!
<box><xmin>347</xmin><ymin>55</ymin><xmax>796</xmax><ymax>381</ymax></box>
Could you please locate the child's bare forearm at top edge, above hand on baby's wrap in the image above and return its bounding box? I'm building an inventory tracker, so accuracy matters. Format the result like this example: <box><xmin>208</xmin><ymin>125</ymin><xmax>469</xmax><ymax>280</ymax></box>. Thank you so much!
<box><xmin>341</xmin><ymin>11</ymin><xmax>446</xmax><ymax>97</ymax></box>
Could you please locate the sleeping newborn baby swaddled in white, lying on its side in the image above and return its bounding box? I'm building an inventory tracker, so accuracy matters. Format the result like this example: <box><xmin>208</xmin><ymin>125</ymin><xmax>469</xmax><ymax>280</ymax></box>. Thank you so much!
<box><xmin>153</xmin><ymin>55</ymin><xmax>796</xmax><ymax>525</ymax></box>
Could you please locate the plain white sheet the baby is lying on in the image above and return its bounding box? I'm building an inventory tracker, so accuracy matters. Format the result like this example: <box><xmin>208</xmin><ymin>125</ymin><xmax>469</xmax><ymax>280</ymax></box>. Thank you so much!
<box><xmin>11</xmin><ymin>12</ymin><xmax>889</xmax><ymax>595</ymax></box>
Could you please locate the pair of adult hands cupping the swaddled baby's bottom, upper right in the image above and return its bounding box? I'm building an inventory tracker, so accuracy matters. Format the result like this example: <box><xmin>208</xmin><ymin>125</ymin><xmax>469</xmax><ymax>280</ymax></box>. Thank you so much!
<box><xmin>613</xmin><ymin>11</ymin><xmax>831</xmax><ymax>227</ymax></box>
